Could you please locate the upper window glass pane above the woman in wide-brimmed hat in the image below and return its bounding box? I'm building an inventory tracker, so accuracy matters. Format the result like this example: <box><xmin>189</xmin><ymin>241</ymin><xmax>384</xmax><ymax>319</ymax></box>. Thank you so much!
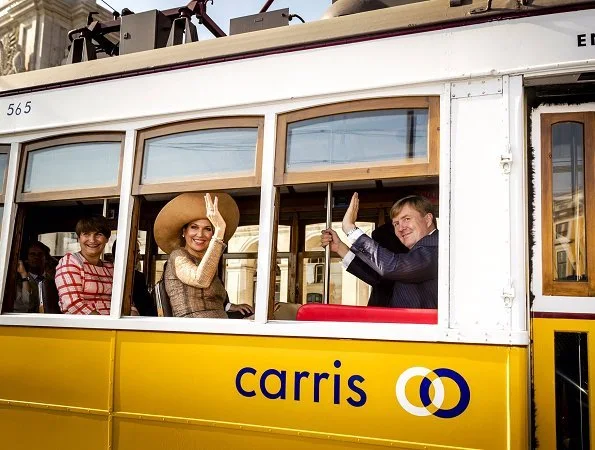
<box><xmin>141</xmin><ymin>128</ymin><xmax>258</xmax><ymax>184</ymax></box>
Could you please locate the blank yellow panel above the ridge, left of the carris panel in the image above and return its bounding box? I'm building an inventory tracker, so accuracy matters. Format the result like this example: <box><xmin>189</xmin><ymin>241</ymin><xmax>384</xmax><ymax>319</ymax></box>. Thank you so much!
<box><xmin>0</xmin><ymin>327</ymin><xmax>116</xmax><ymax>410</ymax></box>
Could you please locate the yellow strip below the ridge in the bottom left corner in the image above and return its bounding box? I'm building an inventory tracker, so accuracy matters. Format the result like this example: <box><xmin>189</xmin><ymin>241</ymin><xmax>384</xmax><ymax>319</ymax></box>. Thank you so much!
<box><xmin>0</xmin><ymin>406</ymin><xmax>109</xmax><ymax>450</ymax></box>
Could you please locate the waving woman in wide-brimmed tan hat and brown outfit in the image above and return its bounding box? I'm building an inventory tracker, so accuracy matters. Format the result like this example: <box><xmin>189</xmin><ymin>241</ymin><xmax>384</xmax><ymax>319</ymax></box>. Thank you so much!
<box><xmin>155</xmin><ymin>192</ymin><xmax>253</xmax><ymax>319</ymax></box>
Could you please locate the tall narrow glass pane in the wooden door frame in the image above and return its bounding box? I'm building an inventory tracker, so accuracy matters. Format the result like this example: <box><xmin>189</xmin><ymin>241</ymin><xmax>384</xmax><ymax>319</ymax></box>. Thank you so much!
<box><xmin>552</xmin><ymin>122</ymin><xmax>587</xmax><ymax>281</ymax></box>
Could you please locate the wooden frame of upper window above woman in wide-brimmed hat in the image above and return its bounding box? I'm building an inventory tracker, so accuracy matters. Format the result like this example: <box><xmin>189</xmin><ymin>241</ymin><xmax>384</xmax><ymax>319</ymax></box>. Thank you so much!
<box><xmin>132</xmin><ymin>116</ymin><xmax>264</xmax><ymax>195</ymax></box>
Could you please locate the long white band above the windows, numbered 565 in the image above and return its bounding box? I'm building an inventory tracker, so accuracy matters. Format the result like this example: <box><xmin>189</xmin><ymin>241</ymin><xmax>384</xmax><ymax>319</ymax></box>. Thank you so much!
<box><xmin>0</xmin><ymin>10</ymin><xmax>595</xmax><ymax>135</ymax></box>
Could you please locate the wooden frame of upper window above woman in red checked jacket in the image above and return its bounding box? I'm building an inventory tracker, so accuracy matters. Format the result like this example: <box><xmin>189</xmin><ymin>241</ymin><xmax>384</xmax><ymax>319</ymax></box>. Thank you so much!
<box><xmin>16</xmin><ymin>132</ymin><xmax>124</xmax><ymax>203</ymax></box>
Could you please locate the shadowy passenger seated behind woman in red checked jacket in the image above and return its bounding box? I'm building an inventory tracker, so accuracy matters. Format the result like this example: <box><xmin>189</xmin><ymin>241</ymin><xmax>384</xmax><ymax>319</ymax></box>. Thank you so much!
<box><xmin>13</xmin><ymin>241</ymin><xmax>59</xmax><ymax>313</ymax></box>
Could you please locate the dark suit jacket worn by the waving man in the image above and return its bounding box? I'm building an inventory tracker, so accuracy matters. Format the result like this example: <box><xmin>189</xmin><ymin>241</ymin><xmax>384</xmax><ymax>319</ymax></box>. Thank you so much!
<box><xmin>349</xmin><ymin>230</ymin><xmax>438</xmax><ymax>308</ymax></box>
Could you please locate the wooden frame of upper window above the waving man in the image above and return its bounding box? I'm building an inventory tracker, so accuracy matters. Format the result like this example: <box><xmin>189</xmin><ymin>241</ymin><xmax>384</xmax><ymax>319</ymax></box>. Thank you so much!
<box><xmin>275</xmin><ymin>96</ymin><xmax>440</xmax><ymax>186</ymax></box>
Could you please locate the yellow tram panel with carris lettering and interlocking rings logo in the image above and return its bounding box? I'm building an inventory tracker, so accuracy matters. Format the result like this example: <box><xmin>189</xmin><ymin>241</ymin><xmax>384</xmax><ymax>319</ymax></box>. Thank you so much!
<box><xmin>114</xmin><ymin>332</ymin><xmax>528</xmax><ymax>450</ymax></box>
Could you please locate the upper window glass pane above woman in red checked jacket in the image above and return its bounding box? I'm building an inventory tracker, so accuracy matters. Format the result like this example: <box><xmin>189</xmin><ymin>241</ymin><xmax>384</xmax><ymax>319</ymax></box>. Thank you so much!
<box><xmin>23</xmin><ymin>142</ymin><xmax>121</xmax><ymax>192</ymax></box>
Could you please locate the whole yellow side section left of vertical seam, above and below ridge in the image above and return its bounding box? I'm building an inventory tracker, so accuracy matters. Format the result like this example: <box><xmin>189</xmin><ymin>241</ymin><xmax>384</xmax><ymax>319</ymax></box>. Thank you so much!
<box><xmin>0</xmin><ymin>327</ymin><xmax>115</xmax><ymax>450</ymax></box>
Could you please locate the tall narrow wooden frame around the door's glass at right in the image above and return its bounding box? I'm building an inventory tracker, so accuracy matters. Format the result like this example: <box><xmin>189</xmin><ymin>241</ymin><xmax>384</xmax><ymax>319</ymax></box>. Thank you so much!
<box><xmin>541</xmin><ymin>112</ymin><xmax>595</xmax><ymax>297</ymax></box>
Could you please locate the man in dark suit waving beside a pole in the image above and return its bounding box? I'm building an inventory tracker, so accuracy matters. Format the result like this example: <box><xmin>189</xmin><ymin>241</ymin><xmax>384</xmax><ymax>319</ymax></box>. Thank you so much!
<box><xmin>322</xmin><ymin>193</ymin><xmax>438</xmax><ymax>308</ymax></box>
